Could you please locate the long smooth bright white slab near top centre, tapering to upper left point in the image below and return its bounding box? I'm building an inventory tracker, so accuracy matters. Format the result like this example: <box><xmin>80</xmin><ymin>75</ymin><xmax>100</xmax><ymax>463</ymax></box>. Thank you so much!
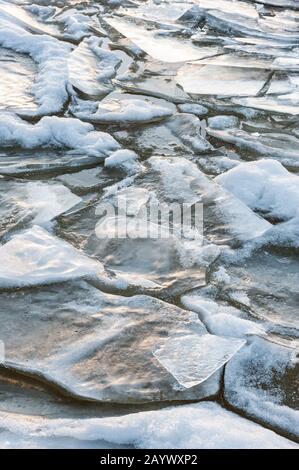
<box><xmin>106</xmin><ymin>18</ymin><xmax>219</xmax><ymax>63</ymax></box>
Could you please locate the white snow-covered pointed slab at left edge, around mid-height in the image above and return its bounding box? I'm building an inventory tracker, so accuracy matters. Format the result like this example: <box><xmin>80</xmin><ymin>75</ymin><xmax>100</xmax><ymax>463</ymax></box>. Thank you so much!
<box><xmin>0</xmin><ymin>225</ymin><xmax>103</xmax><ymax>289</ymax></box>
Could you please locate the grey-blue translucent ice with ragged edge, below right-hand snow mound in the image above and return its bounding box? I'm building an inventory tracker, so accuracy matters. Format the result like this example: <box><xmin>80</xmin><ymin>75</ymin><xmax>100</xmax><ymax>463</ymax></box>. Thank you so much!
<box><xmin>221</xmin><ymin>247</ymin><xmax>299</xmax><ymax>335</ymax></box>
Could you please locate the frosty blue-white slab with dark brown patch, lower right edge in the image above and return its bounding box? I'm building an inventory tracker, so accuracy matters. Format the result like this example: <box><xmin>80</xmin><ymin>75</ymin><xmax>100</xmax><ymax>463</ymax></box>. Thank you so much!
<box><xmin>224</xmin><ymin>337</ymin><xmax>299</xmax><ymax>439</ymax></box>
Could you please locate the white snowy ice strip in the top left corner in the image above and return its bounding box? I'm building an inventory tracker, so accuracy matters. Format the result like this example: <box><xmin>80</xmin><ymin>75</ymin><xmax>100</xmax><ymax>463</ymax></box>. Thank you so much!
<box><xmin>0</xmin><ymin>0</ymin><xmax>62</xmax><ymax>38</ymax></box>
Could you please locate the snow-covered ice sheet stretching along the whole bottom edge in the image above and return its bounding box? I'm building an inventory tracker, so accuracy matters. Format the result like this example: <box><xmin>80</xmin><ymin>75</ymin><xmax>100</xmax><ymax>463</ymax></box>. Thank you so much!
<box><xmin>0</xmin><ymin>402</ymin><xmax>298</xmax><ymax>449</ymax></box>
